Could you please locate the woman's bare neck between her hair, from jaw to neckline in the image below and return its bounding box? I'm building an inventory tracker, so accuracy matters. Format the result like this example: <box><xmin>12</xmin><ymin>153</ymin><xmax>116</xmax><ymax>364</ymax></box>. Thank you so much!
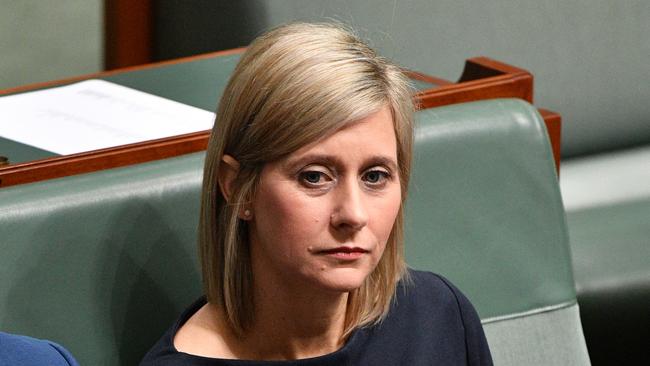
<box><xmin>235</xmin><ymin>276</ymin><xmax>348</xmax><ymax>360</ymax></box>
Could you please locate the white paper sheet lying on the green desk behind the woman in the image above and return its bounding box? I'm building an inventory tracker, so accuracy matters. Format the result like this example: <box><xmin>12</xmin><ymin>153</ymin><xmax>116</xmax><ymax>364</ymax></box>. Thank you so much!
<box><xmin>0</xmin><ymin>80</ymin><xmax>214</xmax><ymax>155</ymax></box>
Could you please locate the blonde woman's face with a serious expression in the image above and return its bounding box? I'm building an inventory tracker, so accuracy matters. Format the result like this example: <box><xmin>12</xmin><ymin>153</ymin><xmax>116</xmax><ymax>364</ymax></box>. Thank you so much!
<box><xmin>250</xmin><ymin>107</ymin><xmax>401</xmax><ymax>291</ymax></box>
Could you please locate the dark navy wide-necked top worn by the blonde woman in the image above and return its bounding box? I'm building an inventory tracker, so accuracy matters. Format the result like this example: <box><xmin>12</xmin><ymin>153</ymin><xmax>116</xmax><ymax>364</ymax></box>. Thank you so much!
<box><xmin>141</xmin><ymin>271</ymin><xmax>492</xmax><ymax>366</ymax></box>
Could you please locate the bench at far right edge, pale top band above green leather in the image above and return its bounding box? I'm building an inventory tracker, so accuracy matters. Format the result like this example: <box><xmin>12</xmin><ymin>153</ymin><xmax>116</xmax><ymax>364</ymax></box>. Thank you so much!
<box><xmin>560</xmin><ymin>150</ymin><xmax>650</xmax><ymax>365</ymax></box>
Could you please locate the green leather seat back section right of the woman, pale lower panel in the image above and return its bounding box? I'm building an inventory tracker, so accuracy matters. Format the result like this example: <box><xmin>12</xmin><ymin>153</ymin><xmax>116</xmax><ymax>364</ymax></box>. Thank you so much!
<box><xmin>406</xmin><ymin>99</ymin><xmax>589</xmax><ymax>365</ymax></box>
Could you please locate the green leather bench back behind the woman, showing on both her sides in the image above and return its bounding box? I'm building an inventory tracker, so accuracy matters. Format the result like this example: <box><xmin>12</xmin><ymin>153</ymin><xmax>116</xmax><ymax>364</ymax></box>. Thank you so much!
<box><xmin>0</xmin><ymin>100</ymin><xmax>589</xmax><ymax>365</ymax></box>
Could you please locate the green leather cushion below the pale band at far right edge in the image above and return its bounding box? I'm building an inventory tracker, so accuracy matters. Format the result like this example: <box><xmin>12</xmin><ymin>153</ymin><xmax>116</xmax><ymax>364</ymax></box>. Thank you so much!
<box><xmin>567</xmin><ymin>198</ymin><xmax>650</xmax><ymax>365</ymax></box>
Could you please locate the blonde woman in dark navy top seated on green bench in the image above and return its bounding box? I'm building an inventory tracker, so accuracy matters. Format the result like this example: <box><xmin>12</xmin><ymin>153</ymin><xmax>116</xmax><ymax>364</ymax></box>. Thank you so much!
<box><xmin>142</xmin><ymin>23</ymin><xmax>491</xmax><ymax>365</ymax></box>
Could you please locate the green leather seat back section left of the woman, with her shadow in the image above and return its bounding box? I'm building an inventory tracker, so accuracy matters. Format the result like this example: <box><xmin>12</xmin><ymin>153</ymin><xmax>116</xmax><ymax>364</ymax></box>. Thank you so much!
<box><xmin>0</xmin><ymin>154</ymin><xmax>203</xmax><ymax>365</ymax></box>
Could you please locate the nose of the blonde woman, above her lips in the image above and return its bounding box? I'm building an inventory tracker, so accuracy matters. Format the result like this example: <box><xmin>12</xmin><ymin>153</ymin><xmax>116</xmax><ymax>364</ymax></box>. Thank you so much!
<box><xmin>330</xmin><ymin>181</ymin><xmax>368</xmax><ymax>231</ymax></box>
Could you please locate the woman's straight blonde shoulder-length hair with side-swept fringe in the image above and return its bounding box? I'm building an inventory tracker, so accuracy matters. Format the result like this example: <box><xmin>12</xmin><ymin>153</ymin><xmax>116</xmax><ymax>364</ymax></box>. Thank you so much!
<box><xmin>199</xmin><ymin>23</ymin><xmax>414</xmax><ymax>336</ymax></box>
